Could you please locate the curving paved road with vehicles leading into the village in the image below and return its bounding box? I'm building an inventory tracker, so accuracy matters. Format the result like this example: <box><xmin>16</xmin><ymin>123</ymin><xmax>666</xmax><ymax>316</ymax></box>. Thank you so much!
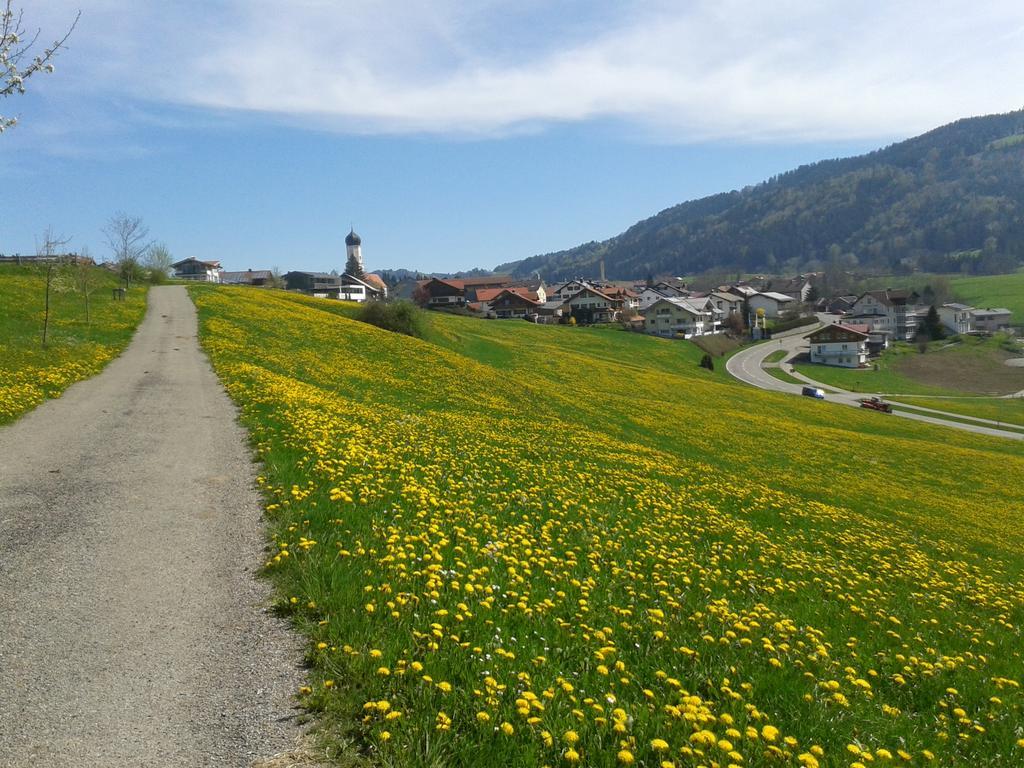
<box><xmin>726</xmin><ymin>315</ymin><xmax>1024</xmax><ymax>440</ymax></box>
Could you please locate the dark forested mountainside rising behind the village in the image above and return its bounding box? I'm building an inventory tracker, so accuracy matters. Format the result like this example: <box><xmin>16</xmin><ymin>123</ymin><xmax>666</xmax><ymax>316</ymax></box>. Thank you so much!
<box><xmin>496</xmin><ymin>111</ymin><xmax>1024</xmax><ymax>281</ymax></box>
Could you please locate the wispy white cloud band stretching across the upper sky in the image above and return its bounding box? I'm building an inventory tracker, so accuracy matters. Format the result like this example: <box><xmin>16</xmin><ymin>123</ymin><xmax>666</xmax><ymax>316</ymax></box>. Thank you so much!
<box><xmin>28</xmin><ymin>0</ymin><xmax>1024</xmax><ymax>141</ymax></box>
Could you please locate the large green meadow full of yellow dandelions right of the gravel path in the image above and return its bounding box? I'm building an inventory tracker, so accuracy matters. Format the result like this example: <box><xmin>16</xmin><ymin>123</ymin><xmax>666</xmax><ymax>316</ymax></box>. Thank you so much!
<box><xmin>190</xmin><ymin>286</ymin><xmax>1024</xmax><ymax>768</ymax></box>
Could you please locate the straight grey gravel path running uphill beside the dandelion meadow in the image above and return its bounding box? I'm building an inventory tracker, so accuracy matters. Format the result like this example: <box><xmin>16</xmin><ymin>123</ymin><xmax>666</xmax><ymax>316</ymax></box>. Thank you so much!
<box><xmin>0</xmin><ymin>286</ymin><xmax>299</xmax><ymax>768</ymax></box>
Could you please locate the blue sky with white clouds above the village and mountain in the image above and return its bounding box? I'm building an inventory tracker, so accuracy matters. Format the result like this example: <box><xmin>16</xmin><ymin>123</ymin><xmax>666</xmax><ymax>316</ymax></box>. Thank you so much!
<box><xmin>0</xmin><ymin>0</ymin><xmax>1024</xmax><ymax>271</ymax></box>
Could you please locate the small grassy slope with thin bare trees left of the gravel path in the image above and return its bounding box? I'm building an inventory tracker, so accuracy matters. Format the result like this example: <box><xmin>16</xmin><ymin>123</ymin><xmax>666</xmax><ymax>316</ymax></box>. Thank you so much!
<box><xmin>0</xmin><ymin>264</ymin><xmax>145</xmax><ymax>424</ymax></box>
